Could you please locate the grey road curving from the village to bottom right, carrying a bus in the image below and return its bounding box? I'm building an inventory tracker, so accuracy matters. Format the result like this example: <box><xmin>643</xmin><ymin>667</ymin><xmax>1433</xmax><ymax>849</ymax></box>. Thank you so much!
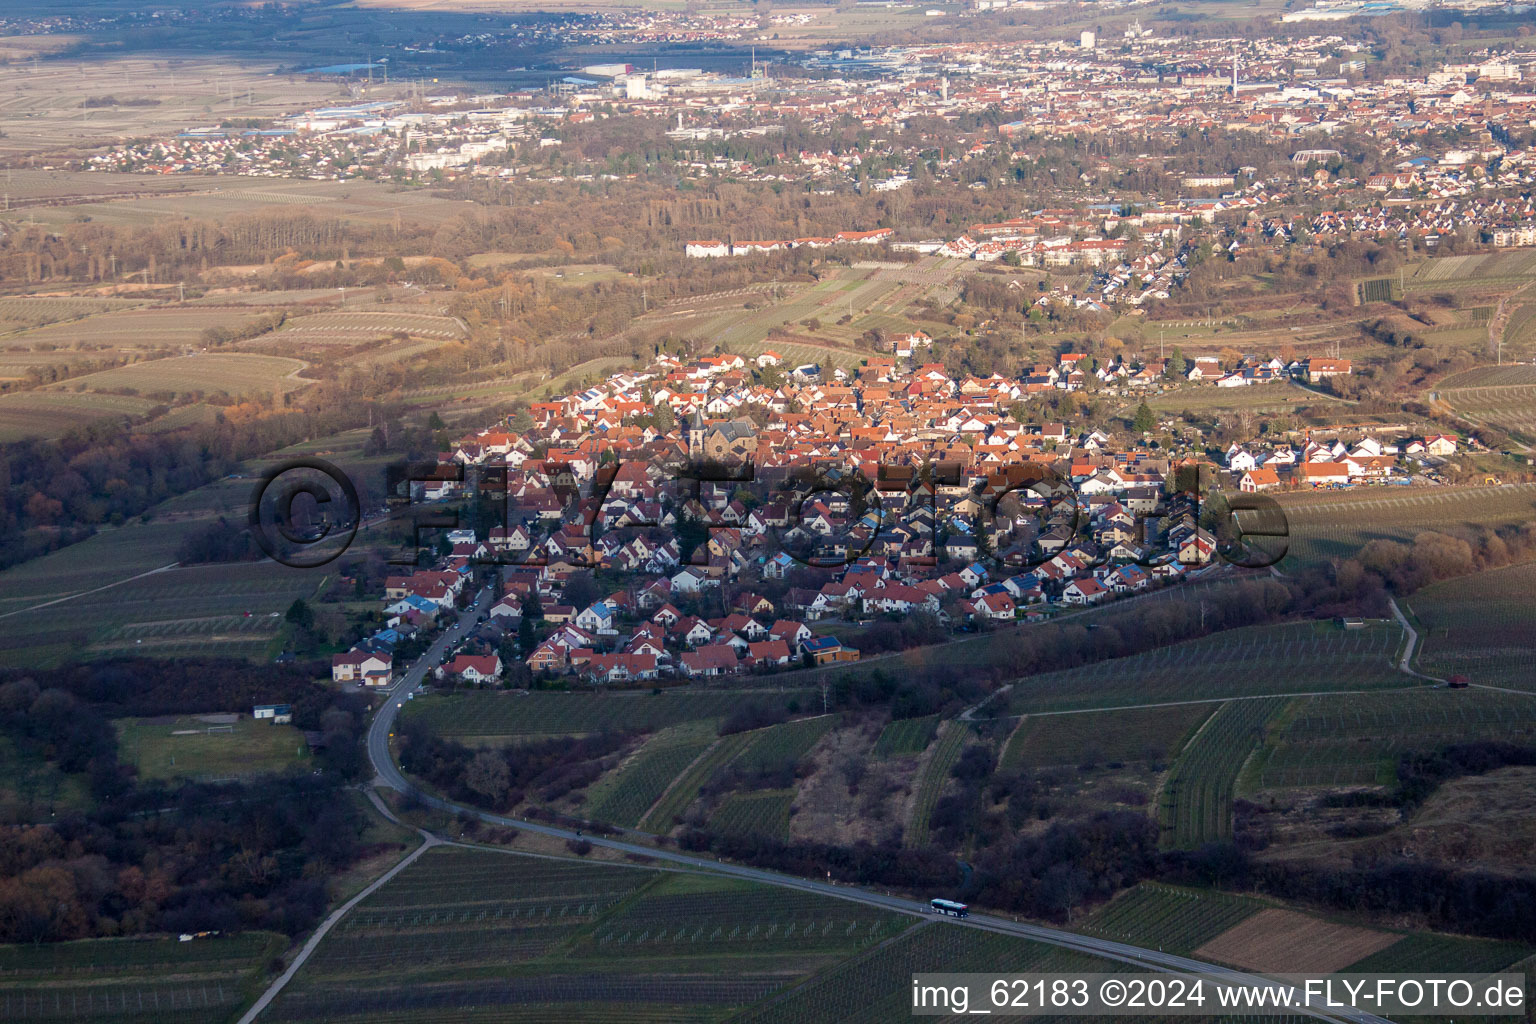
<box><xmin>353</xmin><ymin>588</ymin><xmax>1390</xmax><ymax>1024</ymax></box>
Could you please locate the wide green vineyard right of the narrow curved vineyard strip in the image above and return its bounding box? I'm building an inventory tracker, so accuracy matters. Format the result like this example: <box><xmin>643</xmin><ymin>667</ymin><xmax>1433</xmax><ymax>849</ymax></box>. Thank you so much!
<box><xmin>1246</xmin><ymin>688</ymin><xmax>1536</xmax><ymax>789</ymax></box>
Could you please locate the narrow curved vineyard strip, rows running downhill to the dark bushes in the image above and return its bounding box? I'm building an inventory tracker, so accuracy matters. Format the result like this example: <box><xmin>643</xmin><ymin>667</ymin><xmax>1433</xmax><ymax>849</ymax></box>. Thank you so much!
<box><xmin>1158</xmin><ymin>697</ymin><xmax>1286</xmax><ymax>849</ymax></box>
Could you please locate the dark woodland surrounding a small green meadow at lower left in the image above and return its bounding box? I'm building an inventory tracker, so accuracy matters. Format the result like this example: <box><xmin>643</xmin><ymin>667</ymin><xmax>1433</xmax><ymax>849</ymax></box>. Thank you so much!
<box><xmin>0</xmin><ymin>659</ymin><xmax>369</xmax><ymax>943</ymax></box>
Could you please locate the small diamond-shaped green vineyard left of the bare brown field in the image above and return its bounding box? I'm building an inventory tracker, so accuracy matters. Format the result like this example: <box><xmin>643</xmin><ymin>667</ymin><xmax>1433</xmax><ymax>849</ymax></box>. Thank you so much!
<box><xmin>1080</xmin><ymin>883</ymin><xmax>1269</xmax><ymax>956</ymax></box>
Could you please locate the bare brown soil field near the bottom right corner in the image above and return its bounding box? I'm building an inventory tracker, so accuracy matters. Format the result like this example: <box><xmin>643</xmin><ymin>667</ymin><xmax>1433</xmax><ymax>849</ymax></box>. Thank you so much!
<box><xmin>1195</xmin><ymin>909</ymin><xmax>1402</xmax><ymax>973</ymax></box>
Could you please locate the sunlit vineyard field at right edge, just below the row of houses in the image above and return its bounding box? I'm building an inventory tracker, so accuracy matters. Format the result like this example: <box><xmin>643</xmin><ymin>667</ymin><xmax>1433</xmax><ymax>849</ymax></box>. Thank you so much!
<box><xmin>1278</xmin><ymin>484</ymin><xmax>1536</xmax><ymax>570</ymax></box>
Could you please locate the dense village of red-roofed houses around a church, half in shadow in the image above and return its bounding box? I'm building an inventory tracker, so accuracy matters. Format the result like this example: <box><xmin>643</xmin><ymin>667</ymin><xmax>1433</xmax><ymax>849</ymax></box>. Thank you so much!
<box><xmin>333</xmin><ymin>342</ymin><xmax>1467</xmax><ymax>686</ymax></box>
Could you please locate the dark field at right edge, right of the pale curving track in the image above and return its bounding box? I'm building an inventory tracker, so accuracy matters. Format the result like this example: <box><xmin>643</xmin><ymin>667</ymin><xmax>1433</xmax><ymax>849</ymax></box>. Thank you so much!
<box><xmin>1407</xmin><ymin>563</ymin><xmax>1536</xmax><ymax>689</ymax></box>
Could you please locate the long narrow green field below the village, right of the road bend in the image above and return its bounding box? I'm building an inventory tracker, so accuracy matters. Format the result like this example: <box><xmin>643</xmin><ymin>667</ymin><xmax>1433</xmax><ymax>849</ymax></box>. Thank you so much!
<box><xmin>409</xmin><ymin>689</ymin><xmax>813</xmax><ymax>737</ymax></box>
